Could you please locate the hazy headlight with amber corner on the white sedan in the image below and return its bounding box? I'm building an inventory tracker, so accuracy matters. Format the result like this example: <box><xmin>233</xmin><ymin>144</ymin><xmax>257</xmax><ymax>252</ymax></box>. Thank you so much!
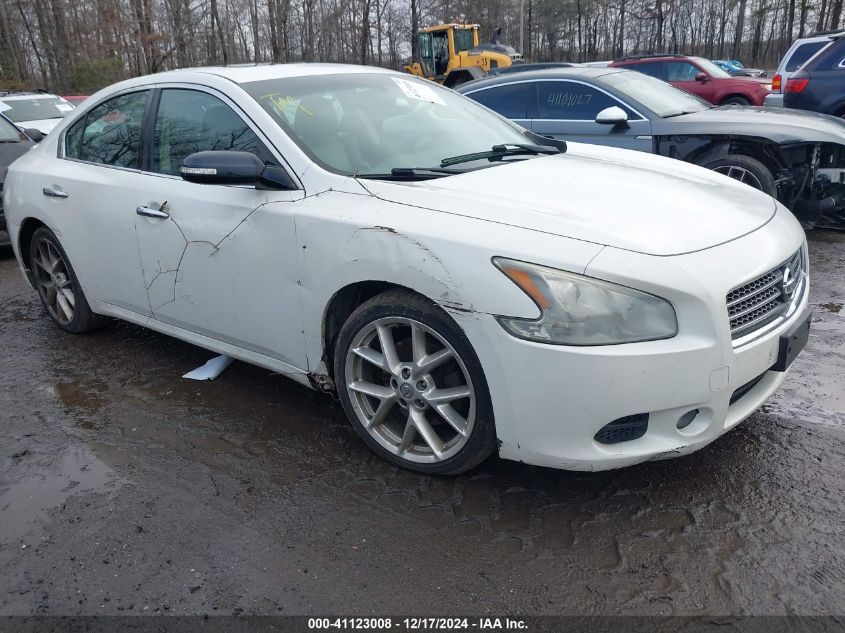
<box><xmin>493</xmin><ymin>257</ymin><xmax>678</xmax><ymax>345</ymax></box>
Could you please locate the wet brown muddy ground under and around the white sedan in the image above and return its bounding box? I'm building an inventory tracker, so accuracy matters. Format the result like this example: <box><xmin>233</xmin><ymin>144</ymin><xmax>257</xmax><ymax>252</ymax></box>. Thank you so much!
<box><xmin>0</xmin><ymin>232</ymin><xmax>845</xmax><ymax>615</ymax></box>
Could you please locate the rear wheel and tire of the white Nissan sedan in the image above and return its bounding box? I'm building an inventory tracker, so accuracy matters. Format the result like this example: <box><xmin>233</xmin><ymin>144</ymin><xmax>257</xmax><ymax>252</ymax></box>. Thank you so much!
<box><xmin>29</xmin><ymin>227</ymin><xmax>108</xmax><ymax>334</ymax></box>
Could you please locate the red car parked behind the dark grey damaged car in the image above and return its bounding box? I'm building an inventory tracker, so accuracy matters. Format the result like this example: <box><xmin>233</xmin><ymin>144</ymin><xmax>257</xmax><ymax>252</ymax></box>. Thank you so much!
<box><xmin>610</xmin><ymin>55</ymin><xmax>772</xmax><ymax>106</ymax></box>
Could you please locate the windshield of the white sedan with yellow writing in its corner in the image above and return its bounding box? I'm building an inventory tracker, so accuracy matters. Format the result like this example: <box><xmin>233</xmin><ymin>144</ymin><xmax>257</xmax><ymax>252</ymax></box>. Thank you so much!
<box><xmin>241</xmin><ymin>73</ymin><xmax>536</xmax><ymax>175</ymax></box>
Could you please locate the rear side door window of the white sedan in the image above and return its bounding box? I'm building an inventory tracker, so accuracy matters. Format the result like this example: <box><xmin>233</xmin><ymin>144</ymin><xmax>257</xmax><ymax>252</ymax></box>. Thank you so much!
<box><xmin>71</xmin><ymin>91</ymin><xmax>149</xmax><ymax>167</ymax></box>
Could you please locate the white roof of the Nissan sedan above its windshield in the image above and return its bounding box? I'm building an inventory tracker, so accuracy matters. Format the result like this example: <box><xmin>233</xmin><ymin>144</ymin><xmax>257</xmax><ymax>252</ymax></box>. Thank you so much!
<box><xmin>144</xmin><ymin>63</ymin><xmax>399</xmax><ymax>84</ymax></box>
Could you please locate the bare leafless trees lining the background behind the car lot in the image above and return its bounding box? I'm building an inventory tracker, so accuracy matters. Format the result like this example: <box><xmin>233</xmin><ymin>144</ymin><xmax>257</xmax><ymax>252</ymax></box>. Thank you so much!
<box><xmin>0</xmin><ymin>0</ymin><xmax>843</xmax><ymax>94</ymax></box>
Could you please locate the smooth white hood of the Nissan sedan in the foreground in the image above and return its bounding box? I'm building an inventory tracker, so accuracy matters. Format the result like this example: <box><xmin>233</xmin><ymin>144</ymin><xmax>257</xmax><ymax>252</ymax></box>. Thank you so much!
<box><xmin>363</xmin><ymin>143</ymin><xmax>776</xmax><ymax>256</ymax></box>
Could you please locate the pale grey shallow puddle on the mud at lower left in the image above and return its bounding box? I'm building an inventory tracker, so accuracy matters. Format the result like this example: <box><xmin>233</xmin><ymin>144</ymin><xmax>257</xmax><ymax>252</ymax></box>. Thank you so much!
<box><xmin>0</xmin><ymin>446</ymin><xmax>122</xmax><ymax>543</ymax></box>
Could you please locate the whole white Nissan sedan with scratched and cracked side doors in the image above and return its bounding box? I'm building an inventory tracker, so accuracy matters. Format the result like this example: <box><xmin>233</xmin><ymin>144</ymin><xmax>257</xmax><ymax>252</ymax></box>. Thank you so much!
<box><xmin>5</xmin><ymin>64</ymin><xmax>809</xmax><ymax>473</ymax></box>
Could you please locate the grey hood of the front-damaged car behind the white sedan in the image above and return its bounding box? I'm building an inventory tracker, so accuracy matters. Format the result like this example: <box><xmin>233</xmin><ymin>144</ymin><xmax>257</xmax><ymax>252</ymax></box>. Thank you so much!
<box><xmin>653</xmin><ymin>106</ymin><xmax>845</xmax><ymax>145</ymax></box>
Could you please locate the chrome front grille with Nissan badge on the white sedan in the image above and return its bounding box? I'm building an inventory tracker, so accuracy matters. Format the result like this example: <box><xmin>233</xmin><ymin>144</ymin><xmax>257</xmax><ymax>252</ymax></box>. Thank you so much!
<box><xmin>725</xmin><ymin>249</ymin><xmax>804</xmax><ymax>339</ymax></box>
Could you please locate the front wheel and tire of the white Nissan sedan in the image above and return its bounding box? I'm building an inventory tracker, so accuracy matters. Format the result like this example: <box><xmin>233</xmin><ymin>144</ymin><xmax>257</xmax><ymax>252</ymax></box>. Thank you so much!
<box><xmin>334</xmin><ymin>290</ymin><xmax>496</xmax><ymax>475</ymax></box>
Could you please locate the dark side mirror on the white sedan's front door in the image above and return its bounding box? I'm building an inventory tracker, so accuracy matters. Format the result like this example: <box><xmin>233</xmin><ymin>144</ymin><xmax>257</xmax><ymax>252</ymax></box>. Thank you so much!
<box><xmin>179</xmin><ymin>151</ymin><xmax>296</xmax><ymax>189</ymax></box>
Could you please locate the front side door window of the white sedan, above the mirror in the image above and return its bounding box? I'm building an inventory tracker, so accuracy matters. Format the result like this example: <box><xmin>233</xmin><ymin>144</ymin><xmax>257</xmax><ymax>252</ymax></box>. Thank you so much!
<box><xmin>152</xmin><ymin>89</ymin><xmax>268</xmax><ymax>175</ymax></box>
